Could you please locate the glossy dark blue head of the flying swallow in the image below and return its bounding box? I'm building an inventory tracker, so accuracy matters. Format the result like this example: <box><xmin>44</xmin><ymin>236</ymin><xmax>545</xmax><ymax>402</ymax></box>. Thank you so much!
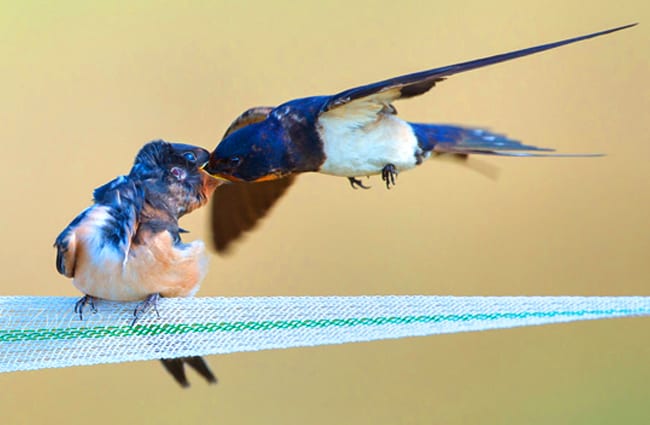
<box><xmin>204</xmin><ymin>120</ymin><xmax>292</xmax><ymax>182</ymax></box>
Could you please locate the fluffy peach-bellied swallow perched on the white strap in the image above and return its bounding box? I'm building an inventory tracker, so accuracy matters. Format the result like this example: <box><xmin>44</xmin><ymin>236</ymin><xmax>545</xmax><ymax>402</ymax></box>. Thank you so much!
<box><xmin>54</xmin><ymin>141</ymin><xmax>219</xmax><ymax>387</ymax></box>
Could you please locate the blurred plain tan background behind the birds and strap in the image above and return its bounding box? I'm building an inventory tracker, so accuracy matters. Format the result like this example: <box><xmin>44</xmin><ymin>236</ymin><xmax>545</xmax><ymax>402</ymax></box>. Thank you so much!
<box><xmin>0</xmin><ymin>0</ymin><xmax>650</xmax><ymax>425</ymax></box>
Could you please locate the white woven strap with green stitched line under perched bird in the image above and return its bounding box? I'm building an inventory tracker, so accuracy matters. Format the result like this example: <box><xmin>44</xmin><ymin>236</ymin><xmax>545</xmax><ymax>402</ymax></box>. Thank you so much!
<box><xmin>0</xmin><ymin>296</ymin><xmax>650</xmax><ymax>372</ymax></box>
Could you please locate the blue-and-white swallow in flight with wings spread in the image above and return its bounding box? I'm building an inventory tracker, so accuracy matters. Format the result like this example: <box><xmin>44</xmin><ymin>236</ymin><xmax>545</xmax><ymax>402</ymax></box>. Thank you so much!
<box><xmin>205</xmin><ymin>24</ymin><xmax>636</xmax><ymax>250</ymax></box>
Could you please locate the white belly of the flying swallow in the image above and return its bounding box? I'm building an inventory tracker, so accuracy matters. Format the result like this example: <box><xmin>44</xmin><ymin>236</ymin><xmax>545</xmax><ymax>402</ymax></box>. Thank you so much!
<box><xmin>319</xmin><ymin>112</ymin><xmax>419</xmax><ymax>177</ymax></box>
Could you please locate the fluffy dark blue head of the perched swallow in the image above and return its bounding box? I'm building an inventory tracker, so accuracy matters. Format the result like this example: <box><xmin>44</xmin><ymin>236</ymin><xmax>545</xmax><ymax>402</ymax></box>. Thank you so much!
<box><xmin>129</xmin><ymin>140</ymin><xmax>219</xmax><ymax>217</ymax></box>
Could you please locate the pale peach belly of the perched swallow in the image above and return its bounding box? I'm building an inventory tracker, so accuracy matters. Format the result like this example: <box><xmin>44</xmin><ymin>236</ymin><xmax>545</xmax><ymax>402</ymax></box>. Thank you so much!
<box><xmin>73</xmin><ymin>227</ymin><xmax>208</xmax><ymax>301</ymax></box>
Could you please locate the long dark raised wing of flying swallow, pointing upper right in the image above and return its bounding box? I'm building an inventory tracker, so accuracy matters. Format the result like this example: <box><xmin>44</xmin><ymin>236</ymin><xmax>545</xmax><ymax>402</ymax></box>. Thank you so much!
<box><xmin>321</xmin><ymin>24</ymin><xmax>636</xmax><ymax>113</ymax></box>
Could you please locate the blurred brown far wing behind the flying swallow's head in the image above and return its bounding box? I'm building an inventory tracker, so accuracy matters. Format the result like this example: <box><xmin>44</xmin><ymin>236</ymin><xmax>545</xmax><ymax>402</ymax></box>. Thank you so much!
<box><xmin>210</xmin><ymin>106</ymin><xmax>295</xmax><ymax>253</ymax></box>
